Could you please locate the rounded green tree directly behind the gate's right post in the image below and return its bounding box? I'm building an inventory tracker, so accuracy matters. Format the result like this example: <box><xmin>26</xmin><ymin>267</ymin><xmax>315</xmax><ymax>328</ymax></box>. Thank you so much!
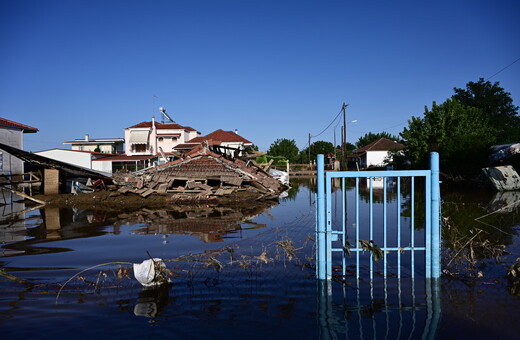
<box><xmin>400</xmin><ymin>99</ymin><xmax>495</xmax><ymax>174</ymax></box>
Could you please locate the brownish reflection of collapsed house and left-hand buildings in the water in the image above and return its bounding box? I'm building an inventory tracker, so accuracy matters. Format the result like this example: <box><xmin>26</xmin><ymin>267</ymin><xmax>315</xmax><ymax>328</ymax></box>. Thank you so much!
<box><xmin>0</xmin><ymin>201</ymin><xmax>277</xmax><ymax>256</ymax></box>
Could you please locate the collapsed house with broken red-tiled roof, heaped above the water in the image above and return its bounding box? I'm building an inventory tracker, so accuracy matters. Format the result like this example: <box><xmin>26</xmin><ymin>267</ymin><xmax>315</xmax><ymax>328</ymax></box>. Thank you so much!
<box><xmin>113</xmin><ymin>145</ymin><xmax>288</xmax><ymax>201</ymax></box>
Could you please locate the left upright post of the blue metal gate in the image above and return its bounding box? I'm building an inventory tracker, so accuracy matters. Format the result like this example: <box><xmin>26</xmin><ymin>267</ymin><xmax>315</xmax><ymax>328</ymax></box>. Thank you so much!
<box><xmin>316</xmin><ymin>155</ymin><xmax>327</xmax><ymax>280</ymax></box>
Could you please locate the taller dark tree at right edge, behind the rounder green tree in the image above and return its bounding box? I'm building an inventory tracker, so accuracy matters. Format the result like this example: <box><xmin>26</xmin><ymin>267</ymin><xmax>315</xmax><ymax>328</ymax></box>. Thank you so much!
<box><xmin>453</xmin><ymin>78</ymin><xmax>520</xmax><ymax>144</ymax></box>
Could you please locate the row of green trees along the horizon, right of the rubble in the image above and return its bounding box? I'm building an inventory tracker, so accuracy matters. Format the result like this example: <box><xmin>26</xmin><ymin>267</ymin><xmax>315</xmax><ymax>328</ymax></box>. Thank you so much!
<box><xmin>267</xmin><ymin>78</ymin><xmax>520</xmax><ymax>174</ymax></box>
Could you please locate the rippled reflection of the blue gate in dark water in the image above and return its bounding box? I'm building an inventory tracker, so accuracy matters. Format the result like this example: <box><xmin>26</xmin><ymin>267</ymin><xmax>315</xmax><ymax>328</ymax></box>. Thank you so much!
<box><xmin>317</xmin><ymin>279</ymin><xmax>441</xmax><ymax>340</ymax></box>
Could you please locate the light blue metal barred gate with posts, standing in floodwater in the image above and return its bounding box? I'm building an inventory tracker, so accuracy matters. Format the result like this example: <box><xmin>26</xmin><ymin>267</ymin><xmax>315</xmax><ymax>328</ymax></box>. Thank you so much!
<box><xmin>316</xmin><ymin>152</ymin><xmax>441</xmax><ymax>280</ymax></box>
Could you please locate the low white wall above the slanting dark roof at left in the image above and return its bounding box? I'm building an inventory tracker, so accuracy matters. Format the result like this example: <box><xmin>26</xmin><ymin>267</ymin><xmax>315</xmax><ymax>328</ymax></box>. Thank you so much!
<box><xmin>35</xmin><ymin>149</ymin><xmax>112</xmax><ymax>173</ymax></box>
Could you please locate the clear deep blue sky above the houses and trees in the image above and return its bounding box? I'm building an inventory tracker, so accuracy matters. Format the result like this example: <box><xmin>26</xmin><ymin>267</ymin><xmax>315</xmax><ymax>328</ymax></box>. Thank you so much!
<box><xmin>0</xmin><ymin>0</ymin><xmax>520</xmax><ymax>151</ymax></box>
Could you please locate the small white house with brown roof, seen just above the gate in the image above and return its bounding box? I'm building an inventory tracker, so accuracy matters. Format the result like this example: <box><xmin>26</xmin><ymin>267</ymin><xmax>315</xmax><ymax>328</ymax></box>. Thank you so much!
<box><xmin>348</xmin><ymin>138</ymin><xmax>405</xmax><ymax>168</ymax></box>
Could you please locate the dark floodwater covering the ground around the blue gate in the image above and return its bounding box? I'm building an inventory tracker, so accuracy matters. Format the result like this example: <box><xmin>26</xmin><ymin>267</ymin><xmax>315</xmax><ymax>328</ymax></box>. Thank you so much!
<box><xmin>0</xmin><ymin>179</ymin><xmax>520</xmax><ymax>339</ymax></box>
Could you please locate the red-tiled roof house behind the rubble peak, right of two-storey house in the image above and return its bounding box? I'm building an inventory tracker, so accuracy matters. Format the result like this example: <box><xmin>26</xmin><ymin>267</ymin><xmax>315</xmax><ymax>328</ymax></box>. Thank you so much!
<box><xmin>174</xmin><ymin>129</ymin><xmax>253</xmax><ymax>155</ymax></box>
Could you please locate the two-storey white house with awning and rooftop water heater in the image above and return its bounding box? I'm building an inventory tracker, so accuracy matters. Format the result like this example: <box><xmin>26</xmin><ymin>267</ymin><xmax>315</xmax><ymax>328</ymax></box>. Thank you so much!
<box><xmin>125</xmin><ymin>117</ymin><xmax>200</xmax><ymax>156</ymax></box>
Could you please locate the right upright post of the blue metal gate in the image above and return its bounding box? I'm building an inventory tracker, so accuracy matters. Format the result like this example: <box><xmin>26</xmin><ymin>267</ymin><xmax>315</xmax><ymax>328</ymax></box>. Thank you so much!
<box><xmin>430</xmin><ymin>152</ymin><xmax>441</xmax><ymax>279</ymax></box>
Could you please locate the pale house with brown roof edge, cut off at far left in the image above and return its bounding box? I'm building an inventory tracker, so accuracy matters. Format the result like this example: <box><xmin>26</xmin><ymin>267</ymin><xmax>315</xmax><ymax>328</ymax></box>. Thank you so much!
<box><xmin>0</xmin><ymin>118</ymin><xmax>38</xmax><ymax>175</ymax></box>
